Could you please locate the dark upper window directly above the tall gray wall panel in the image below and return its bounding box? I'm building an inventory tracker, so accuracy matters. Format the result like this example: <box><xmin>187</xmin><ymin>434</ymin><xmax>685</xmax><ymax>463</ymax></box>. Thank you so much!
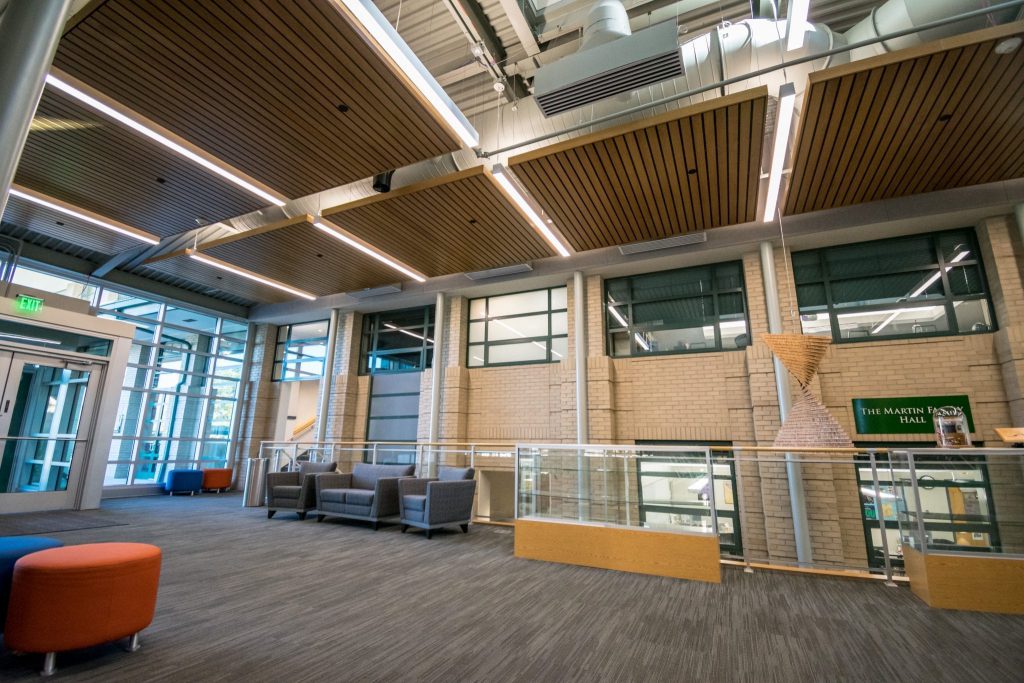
<box><xmin>359</xmin><ymin>306</ymin><xmax>434</xmax><ymax>375</ymax></box>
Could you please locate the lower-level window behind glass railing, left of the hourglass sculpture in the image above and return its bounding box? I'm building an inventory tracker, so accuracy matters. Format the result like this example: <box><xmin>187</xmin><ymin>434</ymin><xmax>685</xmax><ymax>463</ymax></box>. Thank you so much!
<box><xmin>636</xmin><ymin>440</ymin><xmax>743</xmax><ymax>556</ymax></box>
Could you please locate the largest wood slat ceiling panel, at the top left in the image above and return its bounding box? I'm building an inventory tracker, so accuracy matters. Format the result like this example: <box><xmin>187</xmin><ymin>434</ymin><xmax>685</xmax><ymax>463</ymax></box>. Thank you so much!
<box><xmin>54</xmin><ymin>0</ymin><xmax>460</xmax><ymax>197</ymax></box>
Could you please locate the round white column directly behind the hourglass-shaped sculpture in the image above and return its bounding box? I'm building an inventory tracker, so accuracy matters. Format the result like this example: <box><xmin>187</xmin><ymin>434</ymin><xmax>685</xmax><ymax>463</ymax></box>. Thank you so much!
<box><xmin>761</xmin><ymin>241</ymin><xmax>812</xmax><ymax>565</ymax></box>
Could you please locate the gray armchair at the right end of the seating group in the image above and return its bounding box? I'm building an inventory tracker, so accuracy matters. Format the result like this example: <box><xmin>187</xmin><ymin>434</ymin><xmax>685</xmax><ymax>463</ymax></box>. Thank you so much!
<box><xmin>398</xmin><ymin>467</ymin><xmax>476</xmax><ymax>539</ymax></box>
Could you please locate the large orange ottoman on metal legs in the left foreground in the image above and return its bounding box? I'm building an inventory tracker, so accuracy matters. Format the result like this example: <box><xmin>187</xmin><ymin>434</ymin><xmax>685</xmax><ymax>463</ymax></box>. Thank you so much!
<box><xmin>4</xmin><ymin>543</ymin><xmax>161</xmax><ymax>676</ymax></box>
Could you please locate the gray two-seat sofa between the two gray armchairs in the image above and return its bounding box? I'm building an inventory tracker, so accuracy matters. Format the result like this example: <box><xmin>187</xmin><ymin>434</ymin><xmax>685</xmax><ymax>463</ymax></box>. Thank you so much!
<box><xmin>316</xmin><ymin>463</ymin><xmax>416</xmax><ymax>529</ymax></box>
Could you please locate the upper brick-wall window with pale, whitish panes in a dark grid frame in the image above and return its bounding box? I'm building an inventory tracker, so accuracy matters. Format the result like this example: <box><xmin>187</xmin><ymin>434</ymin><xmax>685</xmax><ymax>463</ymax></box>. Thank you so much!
<box><xmin>467</xmin><ymin>287</ymin><xmax>568</xmax><ymax>368</ymax></box>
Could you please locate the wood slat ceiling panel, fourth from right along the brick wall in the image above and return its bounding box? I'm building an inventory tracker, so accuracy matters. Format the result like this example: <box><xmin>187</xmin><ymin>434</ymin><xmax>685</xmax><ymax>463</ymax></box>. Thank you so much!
<box><xmin>197</xmin><ymin>222</ymin><xmax>404</xmax><ymax>298</ymax></box>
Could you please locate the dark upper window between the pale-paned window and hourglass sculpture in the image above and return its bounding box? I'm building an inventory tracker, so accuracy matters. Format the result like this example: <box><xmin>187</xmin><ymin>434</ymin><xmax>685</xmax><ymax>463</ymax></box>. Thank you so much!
<box><xmin>604</xmin><ymin>261</ymin><xmax>751</xmax><ymax>356</ymax></box>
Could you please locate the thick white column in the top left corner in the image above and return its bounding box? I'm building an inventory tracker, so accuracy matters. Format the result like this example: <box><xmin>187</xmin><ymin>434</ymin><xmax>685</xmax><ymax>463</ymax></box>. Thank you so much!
<box><xmin>0</xmin><ymin>0</ymin><xmax>71</xmax><ymax>216</ymax></box>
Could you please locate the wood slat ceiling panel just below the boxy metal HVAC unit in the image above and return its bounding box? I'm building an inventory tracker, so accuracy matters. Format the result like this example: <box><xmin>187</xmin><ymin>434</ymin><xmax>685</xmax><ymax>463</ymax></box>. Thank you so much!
<box><xmin>509</xmin><ymin>87</ymin><xmax>768</xmax><ymax>251</ymax></box>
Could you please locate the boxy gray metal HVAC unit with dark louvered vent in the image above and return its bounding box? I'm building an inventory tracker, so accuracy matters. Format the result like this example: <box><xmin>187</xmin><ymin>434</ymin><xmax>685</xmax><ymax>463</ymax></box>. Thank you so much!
<box><xmin>534</xmin><ymin>22</ymin><xmax>683</xmax><ymax>117</ymax></box>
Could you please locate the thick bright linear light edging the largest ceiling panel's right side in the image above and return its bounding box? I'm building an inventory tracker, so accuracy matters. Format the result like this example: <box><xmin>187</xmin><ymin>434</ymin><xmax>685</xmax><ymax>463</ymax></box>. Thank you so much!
<box><xmin>334</xmin><ymin>0</ymin><xmax>480</xmax><ymax>147</ymax></box>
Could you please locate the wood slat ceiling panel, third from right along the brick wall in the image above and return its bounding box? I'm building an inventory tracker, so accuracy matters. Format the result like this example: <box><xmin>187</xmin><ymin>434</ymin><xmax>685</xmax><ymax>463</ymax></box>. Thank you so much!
<box><xmin>324</xmin><ymin>167</ymin><xmax>554</xmax><ymax>278</ymax></box>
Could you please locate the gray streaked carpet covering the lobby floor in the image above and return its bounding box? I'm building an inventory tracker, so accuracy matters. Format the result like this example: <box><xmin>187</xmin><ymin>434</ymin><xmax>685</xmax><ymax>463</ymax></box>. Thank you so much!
<box><xmin>0</xmin><ymin>495</ymin><xmax>1024</xmax><ymax>682</ymax></box>
